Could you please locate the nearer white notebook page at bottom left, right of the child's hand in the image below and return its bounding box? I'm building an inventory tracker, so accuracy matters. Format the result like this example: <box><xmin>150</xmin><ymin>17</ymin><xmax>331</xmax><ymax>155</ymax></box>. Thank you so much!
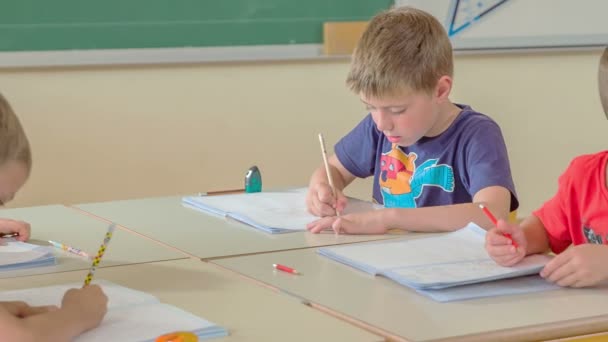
<box><xmin>74</xmin><ymin>303</ymin><xmax>220</xmax><ymax>342</ymax></box>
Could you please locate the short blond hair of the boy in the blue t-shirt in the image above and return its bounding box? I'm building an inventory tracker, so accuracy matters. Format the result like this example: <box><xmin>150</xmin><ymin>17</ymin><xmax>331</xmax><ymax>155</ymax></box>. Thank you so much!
<box><xmin>346</xmin><ymin>7</ymin><xmax>454</xmax><ymax>97</ymax></box>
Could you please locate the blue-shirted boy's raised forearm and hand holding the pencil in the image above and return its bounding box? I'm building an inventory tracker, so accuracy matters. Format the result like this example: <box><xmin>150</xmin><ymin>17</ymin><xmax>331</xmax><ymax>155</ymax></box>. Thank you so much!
<box><xmin>306</xmin><ymin>155</ymin><xmax>356</xmax><ymax>216</ymax></box>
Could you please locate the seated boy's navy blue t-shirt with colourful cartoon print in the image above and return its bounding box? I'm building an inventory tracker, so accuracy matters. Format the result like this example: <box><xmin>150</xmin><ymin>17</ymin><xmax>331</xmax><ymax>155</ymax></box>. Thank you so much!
<box><xmin>335</xmin><ymin>105</ymin><xmax>519</xmax><ymax>211</ymax></box>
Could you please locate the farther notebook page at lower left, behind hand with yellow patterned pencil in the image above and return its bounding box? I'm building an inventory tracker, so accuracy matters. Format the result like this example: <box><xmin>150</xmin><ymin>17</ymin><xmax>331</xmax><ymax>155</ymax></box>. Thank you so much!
<box><xmin>0</xmin><ymin>280</ymin><xmax>158</xmax><ymax>310</ymax></box>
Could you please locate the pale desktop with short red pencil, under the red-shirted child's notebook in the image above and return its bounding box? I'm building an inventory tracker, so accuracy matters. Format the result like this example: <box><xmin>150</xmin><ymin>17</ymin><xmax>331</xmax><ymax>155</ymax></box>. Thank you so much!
<box><xmin>213</xmin><ymin>249</ymin><xmax>608</xmax><ymax>341</ymax></box>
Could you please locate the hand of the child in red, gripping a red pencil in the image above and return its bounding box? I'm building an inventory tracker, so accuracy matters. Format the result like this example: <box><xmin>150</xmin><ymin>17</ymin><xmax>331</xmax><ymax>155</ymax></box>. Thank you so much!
<box><xmin>486</xmin><ymin>220</ymin><xmax>527</xmax><ymax>266</ymax></box>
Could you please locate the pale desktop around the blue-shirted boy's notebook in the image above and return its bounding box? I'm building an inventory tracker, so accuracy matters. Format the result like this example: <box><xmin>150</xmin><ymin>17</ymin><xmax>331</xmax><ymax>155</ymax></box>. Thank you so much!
<box><xmin>75</xmin><ymin>196</ymin><xmax>399</xmax><ymax>259</ymax></box>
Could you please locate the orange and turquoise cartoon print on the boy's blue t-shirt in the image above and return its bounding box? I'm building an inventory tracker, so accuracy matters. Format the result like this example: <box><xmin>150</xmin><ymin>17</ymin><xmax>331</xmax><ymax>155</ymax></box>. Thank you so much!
<box><xmin>379</xmin><ymin>144</ymin><xmax>454</xmax><ymax>208</ymax></box>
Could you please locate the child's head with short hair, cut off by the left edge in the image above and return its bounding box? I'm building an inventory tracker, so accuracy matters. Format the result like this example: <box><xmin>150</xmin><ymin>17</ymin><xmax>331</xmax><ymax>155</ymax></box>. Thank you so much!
<box><xmin>0</xmin><ymin>94</ymin><xmax>32</xmax><ymax>205</ymax></box>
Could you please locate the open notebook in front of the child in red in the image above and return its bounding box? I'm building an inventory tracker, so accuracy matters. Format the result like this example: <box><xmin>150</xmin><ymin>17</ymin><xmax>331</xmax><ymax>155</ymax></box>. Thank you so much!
<box><xmin>318</xmin><ymin>223</ymin><xmax>554</xmax><ymax>301</ymax></box>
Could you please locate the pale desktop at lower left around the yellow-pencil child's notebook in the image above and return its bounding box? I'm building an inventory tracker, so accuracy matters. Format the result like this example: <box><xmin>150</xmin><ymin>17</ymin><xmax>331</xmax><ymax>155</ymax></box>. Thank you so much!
<box><xmin>0</xmin><ymin>259</ymin><xmax>382</xmax><ymax>341</ymax></box>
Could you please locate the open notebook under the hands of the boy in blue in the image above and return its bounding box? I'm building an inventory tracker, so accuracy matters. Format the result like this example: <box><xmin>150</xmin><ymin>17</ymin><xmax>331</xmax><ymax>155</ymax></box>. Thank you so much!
<box><xmin>182</xmin><ymin>188</ymin><xmax>379</xmax><ymax>234</ymax></box>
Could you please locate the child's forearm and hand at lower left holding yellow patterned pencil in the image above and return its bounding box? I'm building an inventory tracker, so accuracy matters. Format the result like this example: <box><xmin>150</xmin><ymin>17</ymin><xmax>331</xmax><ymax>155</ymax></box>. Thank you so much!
<box><xmin>0</xmin><ymin>285</ymin><xmax>108</xmax><ymax>342</ymax></box>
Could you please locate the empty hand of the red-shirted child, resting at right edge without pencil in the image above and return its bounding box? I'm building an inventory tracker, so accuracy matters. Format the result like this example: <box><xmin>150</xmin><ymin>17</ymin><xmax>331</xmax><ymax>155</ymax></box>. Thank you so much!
<box><xmin>540</xmin><ymin>244</ymin><xmax>608</xmax><ymax>287</ymax></box>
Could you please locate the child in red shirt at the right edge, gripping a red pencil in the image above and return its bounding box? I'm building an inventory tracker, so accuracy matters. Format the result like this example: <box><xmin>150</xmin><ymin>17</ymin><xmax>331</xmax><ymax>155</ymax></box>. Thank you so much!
<box><xmin>486</xmin><ymin>48</ymin><xmax>608</xmax><ymax>287</ymax></box>
